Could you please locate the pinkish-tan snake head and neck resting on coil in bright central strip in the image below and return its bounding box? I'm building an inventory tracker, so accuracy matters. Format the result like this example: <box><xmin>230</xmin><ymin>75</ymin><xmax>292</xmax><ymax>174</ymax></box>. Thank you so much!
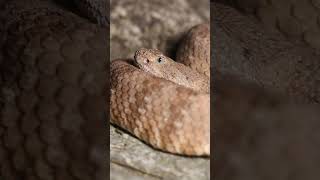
<box><xmin>134</xmin><ymin>48</ymin><xmax>210</xmax><ymax>93</ymax></box>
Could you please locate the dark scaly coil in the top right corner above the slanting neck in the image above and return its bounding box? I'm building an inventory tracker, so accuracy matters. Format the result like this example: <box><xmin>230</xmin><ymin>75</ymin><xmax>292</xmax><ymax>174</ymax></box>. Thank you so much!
<box><xmin>216</xmin><ymin>0</ymin><xmax>320</xmax><ymax>50</ymax></box>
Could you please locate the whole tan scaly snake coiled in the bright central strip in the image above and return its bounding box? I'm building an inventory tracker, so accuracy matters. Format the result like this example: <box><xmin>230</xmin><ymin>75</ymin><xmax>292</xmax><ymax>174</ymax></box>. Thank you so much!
<box><xmin>111</xmin><ymin>25</ymin><xmax>210</xmax><ymax>156</ymax></box>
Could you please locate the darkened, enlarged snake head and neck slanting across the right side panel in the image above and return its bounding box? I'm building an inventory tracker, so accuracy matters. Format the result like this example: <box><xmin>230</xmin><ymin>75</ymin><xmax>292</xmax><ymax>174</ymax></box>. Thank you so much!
<box><xmin>211</xmin><ymin>3</ymin><xmax>320</xmax><ymax>103</ymax></box>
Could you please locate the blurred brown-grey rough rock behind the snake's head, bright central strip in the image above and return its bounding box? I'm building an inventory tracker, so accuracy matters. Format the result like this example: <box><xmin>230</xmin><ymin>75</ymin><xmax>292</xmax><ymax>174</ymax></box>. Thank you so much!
<box><xmin>110</xmin><ymin>0</ymin><xmax>209</xmax><ymax>60</ymax></box>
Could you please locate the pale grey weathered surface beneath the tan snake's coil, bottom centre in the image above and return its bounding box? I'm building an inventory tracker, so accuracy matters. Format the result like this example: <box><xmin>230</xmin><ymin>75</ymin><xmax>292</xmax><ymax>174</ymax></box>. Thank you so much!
<box><xmin>110</xmin><ymin>127</ymin><xmax>210</xmax><ymax>180</ymax></box>
